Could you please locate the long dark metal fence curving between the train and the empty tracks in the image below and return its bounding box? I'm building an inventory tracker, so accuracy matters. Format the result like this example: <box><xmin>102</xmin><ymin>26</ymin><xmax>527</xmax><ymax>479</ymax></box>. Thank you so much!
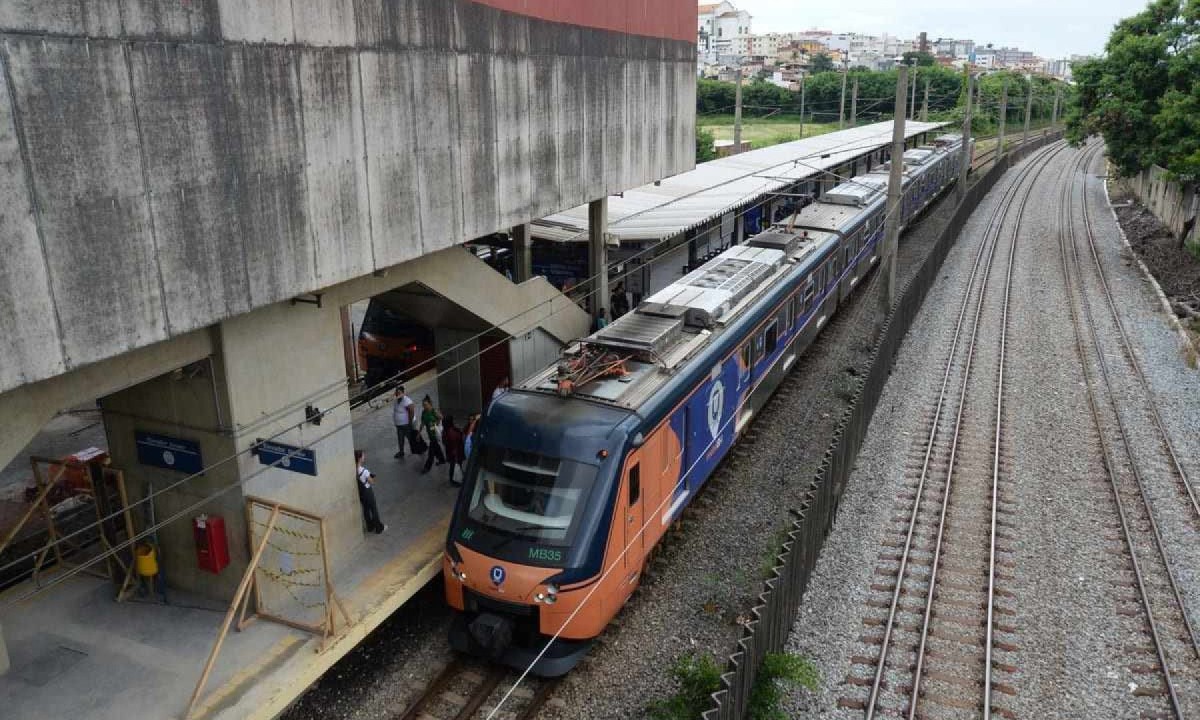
<box><xmin>702</xmin><ymin>132</ymin><xmax>1062</xmax><ymax>720</ymax></box>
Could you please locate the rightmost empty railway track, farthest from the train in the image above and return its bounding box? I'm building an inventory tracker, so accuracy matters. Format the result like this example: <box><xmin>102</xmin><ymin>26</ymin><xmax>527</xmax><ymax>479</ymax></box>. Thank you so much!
<box><xmin>1058</xmin><ymin>144</ymin><xmax>1200</xmax><ymax>720</ymax></box>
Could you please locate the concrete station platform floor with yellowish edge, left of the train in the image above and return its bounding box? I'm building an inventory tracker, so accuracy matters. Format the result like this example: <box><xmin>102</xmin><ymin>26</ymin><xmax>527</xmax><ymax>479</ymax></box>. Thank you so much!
<box><xmin>0</xmin><ymin>383</ymin><xmax>458</xmax><ymax>720</ymax></box>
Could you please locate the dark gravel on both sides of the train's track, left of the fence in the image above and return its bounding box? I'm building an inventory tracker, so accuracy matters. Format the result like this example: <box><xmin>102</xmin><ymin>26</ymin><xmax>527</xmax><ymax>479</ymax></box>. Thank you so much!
<box><xmin>278</xmin><ymin>156</ymin><xmax>1032</xmax><ymax>720</ymax></box>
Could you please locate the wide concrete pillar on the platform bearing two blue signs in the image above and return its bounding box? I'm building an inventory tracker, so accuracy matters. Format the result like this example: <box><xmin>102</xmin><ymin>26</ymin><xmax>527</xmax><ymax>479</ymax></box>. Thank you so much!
<box><xmin>101</xmin><ymin>297</ymin><xmax>362</xmax><ymax>601</ymax></box>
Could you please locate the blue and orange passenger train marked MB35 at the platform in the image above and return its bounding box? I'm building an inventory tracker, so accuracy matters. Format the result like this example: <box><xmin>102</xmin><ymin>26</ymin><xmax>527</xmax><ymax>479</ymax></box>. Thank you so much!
<box><xmin>443</xmin><ymin>130</ymin><xmax>970</xmax><ymax>676</ymax></box>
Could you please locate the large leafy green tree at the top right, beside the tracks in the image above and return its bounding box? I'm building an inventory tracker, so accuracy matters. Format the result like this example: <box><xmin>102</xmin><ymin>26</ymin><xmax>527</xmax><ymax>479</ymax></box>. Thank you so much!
<box><xmin>1067</xmin><ymin>0</ymin><xmax>1200</xmax><ymax>179</ymax></box>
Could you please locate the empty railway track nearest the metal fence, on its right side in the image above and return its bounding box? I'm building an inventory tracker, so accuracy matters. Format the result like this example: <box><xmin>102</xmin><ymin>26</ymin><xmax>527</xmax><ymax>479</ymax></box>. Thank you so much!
<box><xmin>839</xmin><ymin>139</ymin><xmax>1063</xmax><ymax>720</ymax></box>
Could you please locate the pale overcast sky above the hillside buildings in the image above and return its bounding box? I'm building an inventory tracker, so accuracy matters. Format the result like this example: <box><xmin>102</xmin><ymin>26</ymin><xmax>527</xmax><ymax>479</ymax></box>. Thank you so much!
<box><xmin>731</xmin><ymin>0</ymin><xmax>1148</xmax><ymax>58</ymax></box>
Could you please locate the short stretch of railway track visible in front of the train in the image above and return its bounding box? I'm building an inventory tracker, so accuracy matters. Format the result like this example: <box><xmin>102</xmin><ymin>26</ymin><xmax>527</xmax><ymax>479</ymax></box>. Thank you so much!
<box><xmin>396</xmin><ymin>658</ymin><xmax>558</xmax><ymax>720</ymax></box>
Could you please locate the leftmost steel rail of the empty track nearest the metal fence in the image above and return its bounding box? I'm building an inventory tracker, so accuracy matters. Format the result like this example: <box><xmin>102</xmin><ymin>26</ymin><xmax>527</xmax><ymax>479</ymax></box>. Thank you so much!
<box><xmin>866</xmin><ymin>142</ymin><xmax>1064</xmax><ymax>720</ymax></box>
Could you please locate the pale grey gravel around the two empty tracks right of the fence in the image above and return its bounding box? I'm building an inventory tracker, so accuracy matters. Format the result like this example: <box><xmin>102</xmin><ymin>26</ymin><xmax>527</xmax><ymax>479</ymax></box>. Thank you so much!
<box><xmin>786</xmin><ymin>142</ymin><xmax>1200</xmax><ymax>718</ymax></box>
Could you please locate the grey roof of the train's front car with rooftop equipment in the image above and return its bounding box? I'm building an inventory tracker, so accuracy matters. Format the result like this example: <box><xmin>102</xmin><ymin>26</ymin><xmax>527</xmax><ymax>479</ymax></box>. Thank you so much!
<box><xmin>521</xmin><ymin>232</ymin><xmax>828</xmax><ymax>409</ymax></box>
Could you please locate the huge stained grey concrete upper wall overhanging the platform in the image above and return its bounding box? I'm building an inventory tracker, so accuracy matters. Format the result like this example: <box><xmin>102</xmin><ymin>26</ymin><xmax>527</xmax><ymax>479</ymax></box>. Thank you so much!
<box><xmin>0</xmin><ymin>0</ymin><xmax>695</xmax><ymax>392</ymax></box>
